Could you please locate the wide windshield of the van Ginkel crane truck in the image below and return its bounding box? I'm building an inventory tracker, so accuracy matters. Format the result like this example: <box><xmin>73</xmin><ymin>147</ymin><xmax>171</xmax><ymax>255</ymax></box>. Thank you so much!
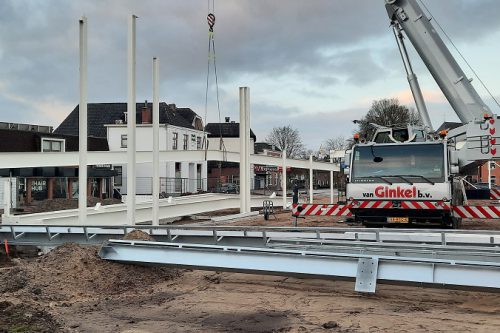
<box><xmin>352</xmin><ymin>144</ymin><xmax>444</xmax><ymax>182</ymax></box>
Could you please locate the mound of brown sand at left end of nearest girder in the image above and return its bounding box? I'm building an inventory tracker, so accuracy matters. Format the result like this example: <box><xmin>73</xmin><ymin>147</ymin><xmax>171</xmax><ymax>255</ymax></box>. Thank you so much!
<box><xmin>0</xmin><ymin>243</ymin><xmax>181</xmax><ymax>301</ymax></box>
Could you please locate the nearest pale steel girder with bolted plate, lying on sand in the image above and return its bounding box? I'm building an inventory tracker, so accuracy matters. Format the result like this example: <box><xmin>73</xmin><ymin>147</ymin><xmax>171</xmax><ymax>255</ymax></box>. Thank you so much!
<box><xmin>99</xmin><ymin>240</ymin><xmax>500</xmax><ymax>292</ymax></box>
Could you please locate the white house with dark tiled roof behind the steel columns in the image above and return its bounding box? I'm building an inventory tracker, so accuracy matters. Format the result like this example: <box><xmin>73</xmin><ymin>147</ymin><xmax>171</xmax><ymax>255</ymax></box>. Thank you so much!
<box><xmin>54</xmin><ymin>101</ymin><xmax>207</xmax><ymax>195</ymax></box>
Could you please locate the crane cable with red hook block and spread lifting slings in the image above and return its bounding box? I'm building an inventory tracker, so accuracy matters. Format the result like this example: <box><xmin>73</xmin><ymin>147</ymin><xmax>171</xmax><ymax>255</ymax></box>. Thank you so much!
<box><xmin>203</xmin><ymin>0</ymin><xmax>227</xmax><ymax>162</ymax></box>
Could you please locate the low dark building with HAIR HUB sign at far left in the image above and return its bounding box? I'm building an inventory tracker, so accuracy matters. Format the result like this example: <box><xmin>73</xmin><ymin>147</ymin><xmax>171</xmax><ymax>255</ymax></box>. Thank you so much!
<box><xmin>0</xmin><ymin>123</ymin><xmax>115</xmax><ymax>208</ymax></box>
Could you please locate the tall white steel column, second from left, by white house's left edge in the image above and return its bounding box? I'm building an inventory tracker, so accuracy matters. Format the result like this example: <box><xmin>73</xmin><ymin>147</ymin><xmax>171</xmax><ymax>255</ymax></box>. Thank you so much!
<box><xmin>127</xmin><ymin>15</ymin><xmax>137</xmax><ymax>225</ymax></box>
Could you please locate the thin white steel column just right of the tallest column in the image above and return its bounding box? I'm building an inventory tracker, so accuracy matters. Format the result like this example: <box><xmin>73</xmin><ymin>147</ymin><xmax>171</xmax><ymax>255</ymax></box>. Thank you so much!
<box><xmin>151</xmin><ymin>58</ymin><xmax>160</xmax><ymax>225</ymax></box>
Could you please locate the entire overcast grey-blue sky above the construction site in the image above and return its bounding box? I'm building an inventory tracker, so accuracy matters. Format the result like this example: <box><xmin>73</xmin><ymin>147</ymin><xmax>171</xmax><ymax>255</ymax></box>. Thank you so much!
<box><xmin>0</xmin><ymin>0</ymin><xmax>500</xmax><ymax>149</ymax></box>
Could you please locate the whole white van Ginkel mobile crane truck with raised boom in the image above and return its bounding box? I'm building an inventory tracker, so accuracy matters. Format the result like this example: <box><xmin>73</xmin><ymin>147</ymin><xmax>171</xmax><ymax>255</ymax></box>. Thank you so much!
<box><xmin>346</xmin><ymin>0</ymin><xmax>500</xmax><ymax>227</ymax></box>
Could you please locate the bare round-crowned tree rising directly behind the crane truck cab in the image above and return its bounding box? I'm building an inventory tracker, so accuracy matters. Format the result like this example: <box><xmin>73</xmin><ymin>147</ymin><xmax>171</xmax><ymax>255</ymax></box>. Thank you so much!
<box><xmin>358</xmin><ymin>98</ymin><xmax>422</xmax><ymax>139</ymax></box>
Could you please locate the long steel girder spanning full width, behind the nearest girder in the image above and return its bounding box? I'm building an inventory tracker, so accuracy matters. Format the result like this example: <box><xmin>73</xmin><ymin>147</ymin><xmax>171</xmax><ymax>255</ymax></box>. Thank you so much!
<box><xmin>0</xmin><ymin>224</ymin><xmax>500</xmax><ymax>248</ymax></box>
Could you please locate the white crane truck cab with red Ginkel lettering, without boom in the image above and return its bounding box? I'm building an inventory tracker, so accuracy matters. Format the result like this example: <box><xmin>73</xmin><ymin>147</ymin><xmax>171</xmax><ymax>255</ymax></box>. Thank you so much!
<box><xmin>346</xmin><ymin>126</ymin><xmax>464</xmax><ymax>227</ymax></box>
